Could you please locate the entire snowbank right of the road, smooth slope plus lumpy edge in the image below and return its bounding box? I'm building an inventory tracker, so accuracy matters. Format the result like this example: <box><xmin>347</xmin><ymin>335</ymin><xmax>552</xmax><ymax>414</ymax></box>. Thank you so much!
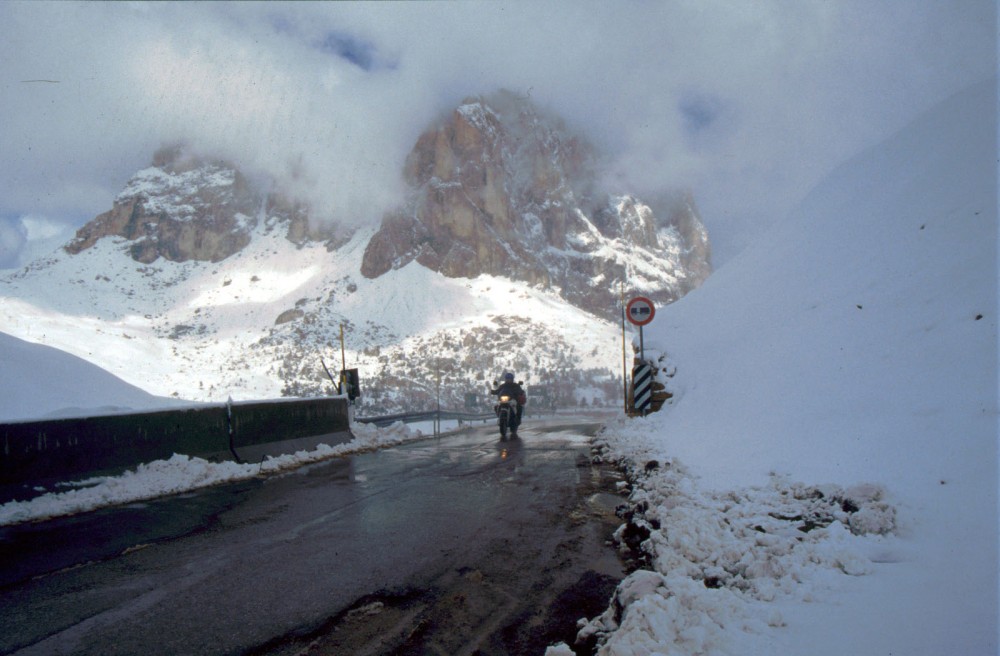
<box><xmin>584</xmin><ymin>80</ymin><xmax>998</xmax><ymax>656</ymax></box>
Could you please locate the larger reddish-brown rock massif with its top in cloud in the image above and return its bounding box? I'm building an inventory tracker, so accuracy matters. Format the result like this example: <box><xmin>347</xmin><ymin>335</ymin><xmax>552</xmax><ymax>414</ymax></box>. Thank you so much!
<box><xmin>361</xmin><ymin>92</ymin><xmax>711</xmax><ymax>314</ymax></box>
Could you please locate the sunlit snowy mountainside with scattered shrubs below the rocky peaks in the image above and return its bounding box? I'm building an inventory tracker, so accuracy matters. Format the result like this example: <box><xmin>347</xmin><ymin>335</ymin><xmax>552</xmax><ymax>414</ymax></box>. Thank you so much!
<box><xmin>0</xmin><ymin>223</ymin><xmax>621</xmax><ymax>412</ymax></box>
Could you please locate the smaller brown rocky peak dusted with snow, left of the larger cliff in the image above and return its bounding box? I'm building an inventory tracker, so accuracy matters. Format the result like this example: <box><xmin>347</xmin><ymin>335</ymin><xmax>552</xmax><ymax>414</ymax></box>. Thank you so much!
<box><xmin>66</xmin><ymin>146</ymin><xmax>348</xmax><ymax>264</ymax></box>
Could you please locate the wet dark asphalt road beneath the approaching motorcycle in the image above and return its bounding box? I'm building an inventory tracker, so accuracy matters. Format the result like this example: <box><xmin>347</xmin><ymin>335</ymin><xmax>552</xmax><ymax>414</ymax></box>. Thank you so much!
<box><xmin>0</xmin><ymin>422</ymin><xmax>622</xmax><ymax>656</ymax></box>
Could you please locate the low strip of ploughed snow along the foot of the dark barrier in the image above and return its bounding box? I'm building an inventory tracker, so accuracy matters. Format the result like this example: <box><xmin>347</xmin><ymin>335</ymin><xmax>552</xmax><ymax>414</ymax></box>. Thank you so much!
<box><xmin>0</xmin><ymin>422</ymin><xmax>423</xmax><ymax>526</ymax></box>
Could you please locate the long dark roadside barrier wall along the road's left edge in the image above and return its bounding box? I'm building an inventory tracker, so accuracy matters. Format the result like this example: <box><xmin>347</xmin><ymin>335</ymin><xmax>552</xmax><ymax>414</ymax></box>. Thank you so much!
<box><xmin>0</xmin><ymin>397</ymin><xmax>353</xmax><ymax>503</ymax></box>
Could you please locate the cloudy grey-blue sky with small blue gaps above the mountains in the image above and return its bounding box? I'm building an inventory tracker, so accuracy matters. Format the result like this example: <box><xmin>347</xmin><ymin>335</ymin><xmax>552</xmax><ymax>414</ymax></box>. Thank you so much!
<box><xmin>0</xmin><ymin>0</ymin><xmax>997</xmax><ymax>267</ymax></box>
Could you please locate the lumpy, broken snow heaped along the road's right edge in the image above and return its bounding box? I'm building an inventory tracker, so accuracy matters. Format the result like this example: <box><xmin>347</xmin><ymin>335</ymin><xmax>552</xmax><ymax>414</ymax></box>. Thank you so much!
<box><xmin>564</xmin><ymin>422</ymin><xmax>897</xmax><ymax>656</ymax></box>
